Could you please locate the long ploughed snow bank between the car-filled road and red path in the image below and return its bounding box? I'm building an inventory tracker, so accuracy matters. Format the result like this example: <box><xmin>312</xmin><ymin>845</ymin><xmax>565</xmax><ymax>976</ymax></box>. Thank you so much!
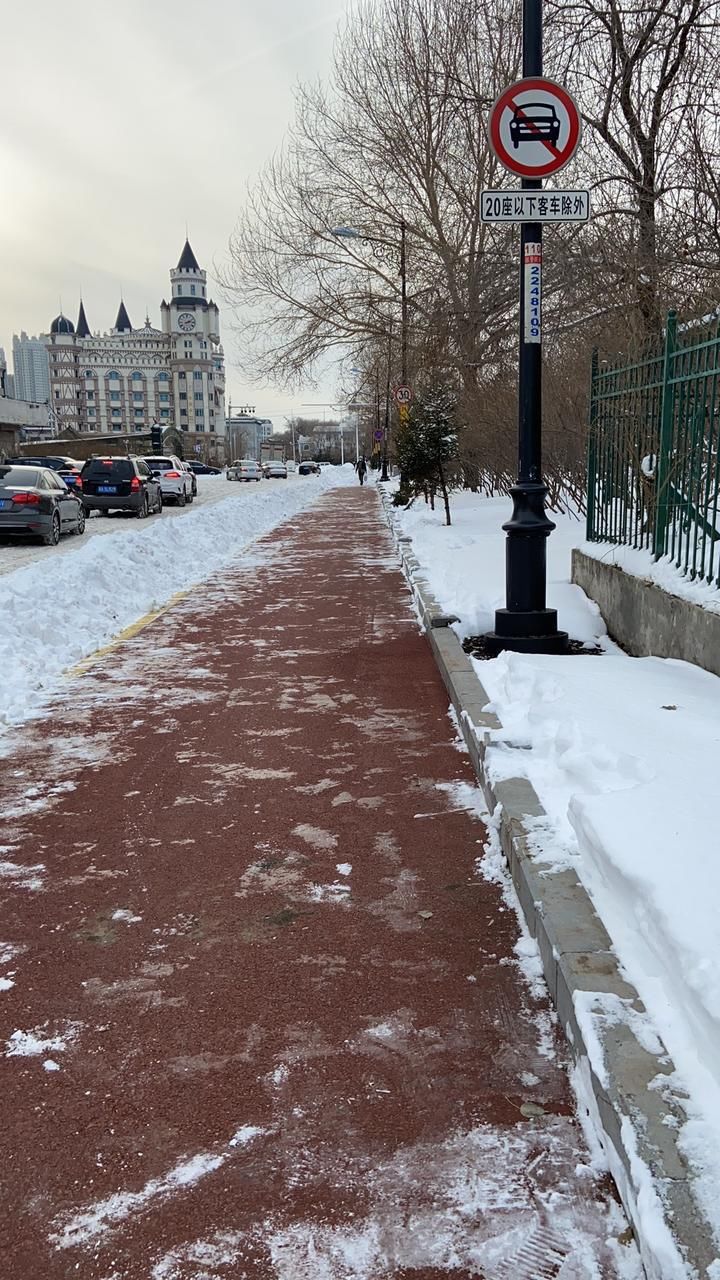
<box><xmin>0</xmin><ymin>466</ymin><xmax>355</xmax><ymax>732</ymax></box>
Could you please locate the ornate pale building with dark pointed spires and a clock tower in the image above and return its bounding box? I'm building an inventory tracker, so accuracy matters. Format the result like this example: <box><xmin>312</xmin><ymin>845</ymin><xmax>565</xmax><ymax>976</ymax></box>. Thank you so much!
<box><xmin>45</xmin><ymin>241</ymin><xmax>225</xmax><ymax>457</ymax></box>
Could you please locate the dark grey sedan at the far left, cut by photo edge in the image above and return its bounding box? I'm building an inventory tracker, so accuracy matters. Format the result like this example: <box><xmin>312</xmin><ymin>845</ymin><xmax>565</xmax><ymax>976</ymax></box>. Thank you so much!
<box><xmin>0</xmin><ymin>462</ymin><xmax>85</xmax><ymax>547</ymax></box>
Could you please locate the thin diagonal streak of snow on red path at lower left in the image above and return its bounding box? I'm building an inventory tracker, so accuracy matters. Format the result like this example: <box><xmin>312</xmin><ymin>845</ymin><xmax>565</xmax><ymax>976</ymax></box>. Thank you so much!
<box><xmin>49</xmin><ymin>1125</ymin><xmax>266</xmax><ymax>1249</ymax></box>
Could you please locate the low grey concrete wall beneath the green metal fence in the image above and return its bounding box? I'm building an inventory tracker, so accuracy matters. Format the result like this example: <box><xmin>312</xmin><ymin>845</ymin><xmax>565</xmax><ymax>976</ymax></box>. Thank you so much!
<box><xmin>573</xmin><ymin>550</ymin><xmax>720</xmax><ymax>676</ymax></box>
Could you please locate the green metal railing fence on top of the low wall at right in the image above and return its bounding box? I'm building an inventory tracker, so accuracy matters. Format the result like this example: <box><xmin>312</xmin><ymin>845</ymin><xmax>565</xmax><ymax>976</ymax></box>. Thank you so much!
<box><xmin>587</xmin><ymin>311</ymin><xmax>720</xmax><ymax>585</ymax></box>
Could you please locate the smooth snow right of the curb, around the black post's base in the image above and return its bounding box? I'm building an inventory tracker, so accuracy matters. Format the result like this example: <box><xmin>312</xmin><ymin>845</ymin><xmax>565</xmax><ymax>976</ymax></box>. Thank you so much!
<box><xmin>398</xmin><ymin>494</ymin><xmax>720</xmax><ymax>1236</ymax></box>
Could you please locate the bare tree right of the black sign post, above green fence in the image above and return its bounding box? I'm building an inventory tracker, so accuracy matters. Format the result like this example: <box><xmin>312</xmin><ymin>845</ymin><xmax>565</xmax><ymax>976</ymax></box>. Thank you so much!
<box><xmin>546</xmin><ymin>0</ymin><xmax>720</xmax><ymax>337</ymax></box>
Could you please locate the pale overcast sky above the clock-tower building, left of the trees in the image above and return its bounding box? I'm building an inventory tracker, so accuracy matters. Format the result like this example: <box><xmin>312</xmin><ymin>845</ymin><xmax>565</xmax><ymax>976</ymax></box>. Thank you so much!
<box><xmin>0</xmin><ymin>0</ymin><xmax>346</xmax><ymax>428</ymax></box>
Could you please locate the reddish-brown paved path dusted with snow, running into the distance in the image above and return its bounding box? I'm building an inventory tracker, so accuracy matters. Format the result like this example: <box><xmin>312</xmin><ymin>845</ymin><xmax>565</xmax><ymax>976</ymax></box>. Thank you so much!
<box><xmin>0</xmin><ymin>488</ymin><xmax>639</xmax><ymax>1280</ymax></box>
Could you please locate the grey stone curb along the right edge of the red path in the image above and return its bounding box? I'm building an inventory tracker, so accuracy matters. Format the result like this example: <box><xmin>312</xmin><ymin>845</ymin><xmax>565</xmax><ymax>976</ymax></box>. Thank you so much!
<box><xmin>378</xmin><ymin>489</ymin><xmax>719</xmax><ymax>1280</ymax></box>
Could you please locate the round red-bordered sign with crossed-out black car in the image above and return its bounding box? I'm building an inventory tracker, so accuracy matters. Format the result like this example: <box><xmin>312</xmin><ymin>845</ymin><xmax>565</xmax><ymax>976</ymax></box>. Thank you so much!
<box><xmin>488</xmin><ymin>77</ymin><xmax>580</xmax><ymax>178</ymax></box>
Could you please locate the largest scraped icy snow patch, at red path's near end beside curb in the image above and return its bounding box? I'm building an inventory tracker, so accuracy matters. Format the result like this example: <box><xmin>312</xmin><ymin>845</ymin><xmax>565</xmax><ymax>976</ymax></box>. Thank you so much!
<box><xmin>150</xmin><ymin>1116</ymin><xmax>643</xmax><ymax>1280</ymax></box>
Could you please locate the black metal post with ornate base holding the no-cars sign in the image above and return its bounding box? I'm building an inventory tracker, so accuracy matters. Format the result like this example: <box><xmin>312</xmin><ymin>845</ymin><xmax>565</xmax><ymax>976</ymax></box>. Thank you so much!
<box><xmin>486</xmin><ymin>0</ymin><xmax>568</xmax><ymax>653</ymax></box>
